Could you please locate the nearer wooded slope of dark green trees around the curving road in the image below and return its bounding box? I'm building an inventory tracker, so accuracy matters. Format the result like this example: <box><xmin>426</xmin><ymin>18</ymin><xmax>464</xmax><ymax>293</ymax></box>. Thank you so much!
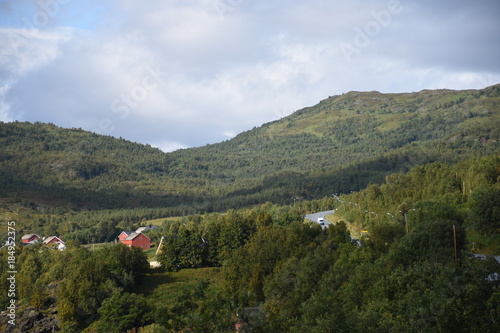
<box><xmin>0</xmin><ymin>154</ymin><xmax>500</xmax><ymax>333</ymax></box>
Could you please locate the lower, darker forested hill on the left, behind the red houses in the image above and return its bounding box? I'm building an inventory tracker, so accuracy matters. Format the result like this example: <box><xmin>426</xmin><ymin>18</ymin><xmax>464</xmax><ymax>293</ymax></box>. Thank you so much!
<box><xmin>0</xmin><ymin>122</ymin><xmax>179</xmax><ymax>207</ymax></box>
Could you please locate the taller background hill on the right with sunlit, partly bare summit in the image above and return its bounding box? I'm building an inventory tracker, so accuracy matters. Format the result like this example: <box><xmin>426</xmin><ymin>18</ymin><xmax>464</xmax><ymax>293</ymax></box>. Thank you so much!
<box><xmin>172</xmin><ymin>86</ymin><xmax>500</xmax><ymax>208</ymax></box>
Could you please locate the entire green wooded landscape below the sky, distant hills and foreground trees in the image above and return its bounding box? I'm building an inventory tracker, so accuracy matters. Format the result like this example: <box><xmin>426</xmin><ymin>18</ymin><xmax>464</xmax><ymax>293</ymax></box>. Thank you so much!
<box><xmin>0</xmin><ymin>85</ymin><xmax>500</xmax><ymax>333</ymax></box>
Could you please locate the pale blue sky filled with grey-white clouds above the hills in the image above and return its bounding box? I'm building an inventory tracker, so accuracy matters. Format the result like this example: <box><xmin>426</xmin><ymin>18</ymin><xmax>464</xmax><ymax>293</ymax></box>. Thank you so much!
<box><xmin>0</xmin><ymin>0</ymin><xmax>500</xmax><ymax>152</ymax></box>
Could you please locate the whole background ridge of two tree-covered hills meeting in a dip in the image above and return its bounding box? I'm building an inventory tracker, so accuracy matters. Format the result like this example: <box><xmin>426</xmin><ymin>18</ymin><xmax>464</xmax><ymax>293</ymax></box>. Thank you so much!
<box><xmin>0</xmin><ymin>85</ymin><xmax>500</xmax><ymax>211</ymax></box>
